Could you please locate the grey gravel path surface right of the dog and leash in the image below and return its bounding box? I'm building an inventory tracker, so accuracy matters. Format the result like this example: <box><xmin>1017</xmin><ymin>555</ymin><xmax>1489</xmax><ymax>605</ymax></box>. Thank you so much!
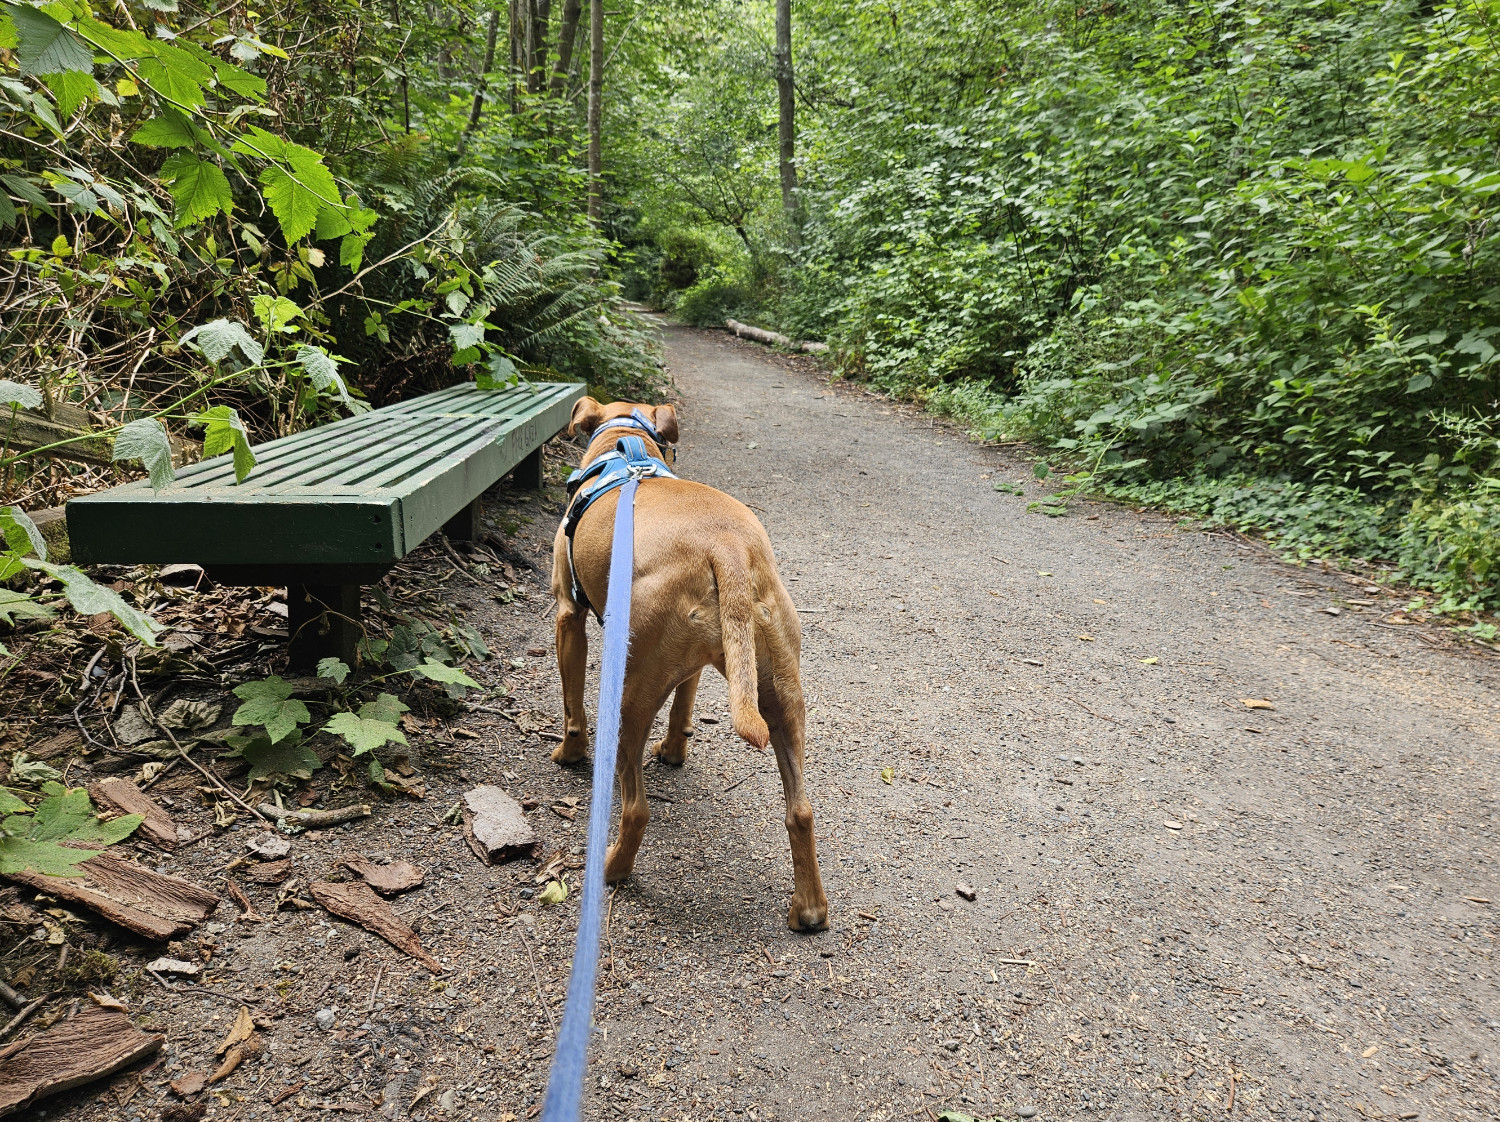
<box><xmin>558</xmin><ymin>332</ymin><xmax>1500</xmax><ymax>1119</ymax></box>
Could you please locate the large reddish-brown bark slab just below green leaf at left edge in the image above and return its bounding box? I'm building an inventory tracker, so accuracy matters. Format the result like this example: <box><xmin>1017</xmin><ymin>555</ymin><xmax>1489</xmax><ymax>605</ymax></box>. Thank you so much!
<box><xmin>6</xmin><ymin>849</ymin><xmax>219</xmax><ymax>941</ymax></box>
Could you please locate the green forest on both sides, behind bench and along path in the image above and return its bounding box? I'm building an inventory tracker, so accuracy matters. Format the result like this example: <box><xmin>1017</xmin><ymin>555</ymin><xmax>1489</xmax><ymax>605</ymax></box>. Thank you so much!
<box><xmin>0</xmin><ymin>0</ymin><xmax>1500</xmax><ymax>621</ymax></box>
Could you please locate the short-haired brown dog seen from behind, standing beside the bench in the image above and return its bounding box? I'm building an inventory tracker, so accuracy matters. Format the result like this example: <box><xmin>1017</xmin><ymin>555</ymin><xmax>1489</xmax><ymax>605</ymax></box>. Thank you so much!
<box><xmin>552</xmin><ymin>398</ymin><xmax>828</xmax><ymax>930</ymax></box>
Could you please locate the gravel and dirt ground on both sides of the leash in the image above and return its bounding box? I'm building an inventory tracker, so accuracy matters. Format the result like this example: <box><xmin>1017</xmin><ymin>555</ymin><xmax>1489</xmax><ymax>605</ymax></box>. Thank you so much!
<box><xmin>35</xmin><ymin>330</ymin><xmax>1500</xmax><ymax>1122</ymax></box>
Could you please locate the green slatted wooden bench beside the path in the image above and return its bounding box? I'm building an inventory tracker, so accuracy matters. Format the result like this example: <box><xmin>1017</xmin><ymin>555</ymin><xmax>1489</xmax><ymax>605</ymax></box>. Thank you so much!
<box><xmin>68</xmin><ymin>383</ymin><xmax>587</xmax><ymax>666</ymax></box>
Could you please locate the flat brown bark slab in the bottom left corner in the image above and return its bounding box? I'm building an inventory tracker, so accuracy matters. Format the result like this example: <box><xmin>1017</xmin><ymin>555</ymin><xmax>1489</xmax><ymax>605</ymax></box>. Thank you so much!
<box><xmin>0</xmin><ymin>1005</ymin><xmax>167</xmax><ymax>1118</ymax></box>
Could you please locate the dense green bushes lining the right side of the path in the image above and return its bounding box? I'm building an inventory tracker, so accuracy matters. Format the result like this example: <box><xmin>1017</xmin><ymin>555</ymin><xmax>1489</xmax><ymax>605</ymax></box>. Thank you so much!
<box><xmin>609</xmin><ymin>0</ymin><xmax>1500</xmax><ymax>639</ymax></box>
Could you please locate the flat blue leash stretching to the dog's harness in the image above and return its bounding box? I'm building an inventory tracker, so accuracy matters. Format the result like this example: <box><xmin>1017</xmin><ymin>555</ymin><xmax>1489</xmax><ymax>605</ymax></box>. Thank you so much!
<box><xmin>542</xmin><ymin>479</ymin><xmax>641</xmax><ymax>1122</ymax></box>
